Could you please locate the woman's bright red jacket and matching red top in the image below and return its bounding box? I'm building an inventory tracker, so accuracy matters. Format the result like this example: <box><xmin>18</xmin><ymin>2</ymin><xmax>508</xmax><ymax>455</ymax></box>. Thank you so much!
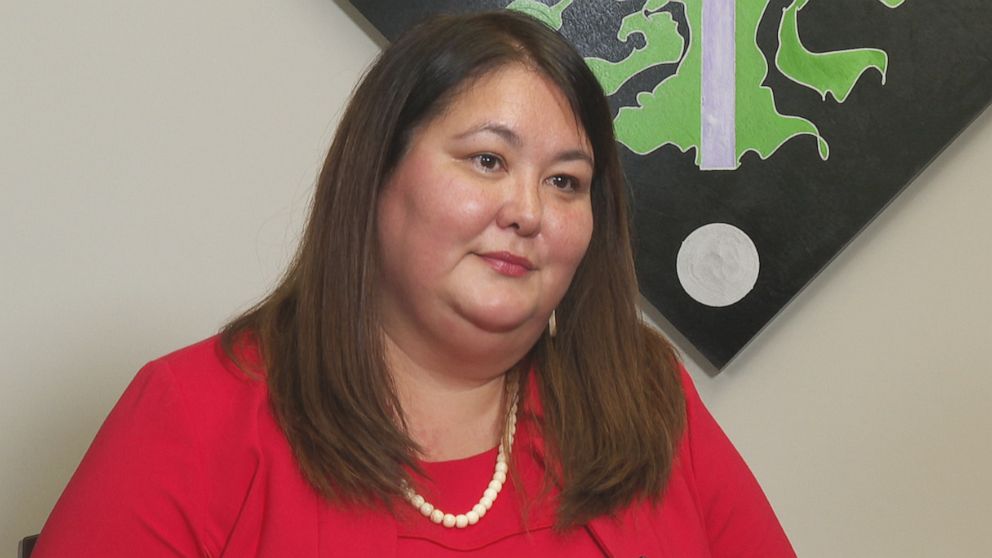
<box><xmin>32</xmin><ymin>338</ymin><xmax>795</xmax><ymax>558</ymax></box>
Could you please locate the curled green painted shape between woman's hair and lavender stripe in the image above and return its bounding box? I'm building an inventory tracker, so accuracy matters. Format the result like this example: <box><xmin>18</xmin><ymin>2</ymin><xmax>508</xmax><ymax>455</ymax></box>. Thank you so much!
<box><xmin>586</xmin><ymin>0</ymin><xmax>685</xmax><ymax>95</ymax></box>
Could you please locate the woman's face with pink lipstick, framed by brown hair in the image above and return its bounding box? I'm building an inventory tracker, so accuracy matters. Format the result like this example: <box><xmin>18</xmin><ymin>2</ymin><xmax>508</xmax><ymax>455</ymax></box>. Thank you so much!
<box><xmin>377</xmin><ymin>65</ymin><xmax>593</xmax><ymax>368</ymax></box>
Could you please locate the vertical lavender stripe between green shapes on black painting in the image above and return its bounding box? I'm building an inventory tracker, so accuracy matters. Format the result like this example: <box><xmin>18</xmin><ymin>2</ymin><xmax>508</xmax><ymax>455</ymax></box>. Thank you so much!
<box><xmin>699</xmin><ymin>0</ymin><xmax>737</xmax><ymax>170</ymax></box>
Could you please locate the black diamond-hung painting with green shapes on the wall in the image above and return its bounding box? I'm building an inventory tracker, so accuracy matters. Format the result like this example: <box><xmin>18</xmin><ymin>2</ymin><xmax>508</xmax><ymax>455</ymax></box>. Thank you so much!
<box><xmin>352</xmin><ymin>0</ymin><xmax>992</xmax><ymax>371</ymax></box>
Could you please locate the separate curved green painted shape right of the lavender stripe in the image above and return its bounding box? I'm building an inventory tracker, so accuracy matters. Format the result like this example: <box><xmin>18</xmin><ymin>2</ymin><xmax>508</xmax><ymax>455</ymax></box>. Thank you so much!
<box><xmin>775</xmin><ymin>0</ymin><xmax>898</xmax><ymax>103</ymax></box>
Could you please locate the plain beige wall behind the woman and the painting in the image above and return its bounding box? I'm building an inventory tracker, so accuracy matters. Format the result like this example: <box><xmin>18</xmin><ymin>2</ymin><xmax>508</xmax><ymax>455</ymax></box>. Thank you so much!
<box><xmin>0</xmin><ymin>0</ymin><xmax>992</xmax><ymax>558</ymax></box>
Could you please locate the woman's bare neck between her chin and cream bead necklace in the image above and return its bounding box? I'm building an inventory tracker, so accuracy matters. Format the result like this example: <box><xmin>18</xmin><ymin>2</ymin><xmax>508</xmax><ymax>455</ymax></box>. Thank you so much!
<box><xmin>386</xmin><ymin>336</ymin><xmax>506</xmax><ymax>461</ymax></box>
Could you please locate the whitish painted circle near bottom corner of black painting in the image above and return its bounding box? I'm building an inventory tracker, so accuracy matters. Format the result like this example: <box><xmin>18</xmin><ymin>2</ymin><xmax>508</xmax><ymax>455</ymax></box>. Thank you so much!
<box><xmin>675</xmin><ymin>223</ymin><xmax>759</xmax><ymax>308</ymax></box>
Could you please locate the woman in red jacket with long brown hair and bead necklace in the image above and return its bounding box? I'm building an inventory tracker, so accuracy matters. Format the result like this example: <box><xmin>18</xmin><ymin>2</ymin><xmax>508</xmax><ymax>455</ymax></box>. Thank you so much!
<box><xmin>36</xmin><ymin>9</ymin><xmax>793</xmax><ymax>558</ymax></box>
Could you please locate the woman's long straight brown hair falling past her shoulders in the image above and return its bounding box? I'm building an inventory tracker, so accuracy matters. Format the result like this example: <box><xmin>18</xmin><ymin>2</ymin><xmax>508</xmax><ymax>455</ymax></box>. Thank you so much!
<box><xmin>222</xmin><ymin>12</ymin><xmax>685</xmax><ymax>528</ymax></box>
